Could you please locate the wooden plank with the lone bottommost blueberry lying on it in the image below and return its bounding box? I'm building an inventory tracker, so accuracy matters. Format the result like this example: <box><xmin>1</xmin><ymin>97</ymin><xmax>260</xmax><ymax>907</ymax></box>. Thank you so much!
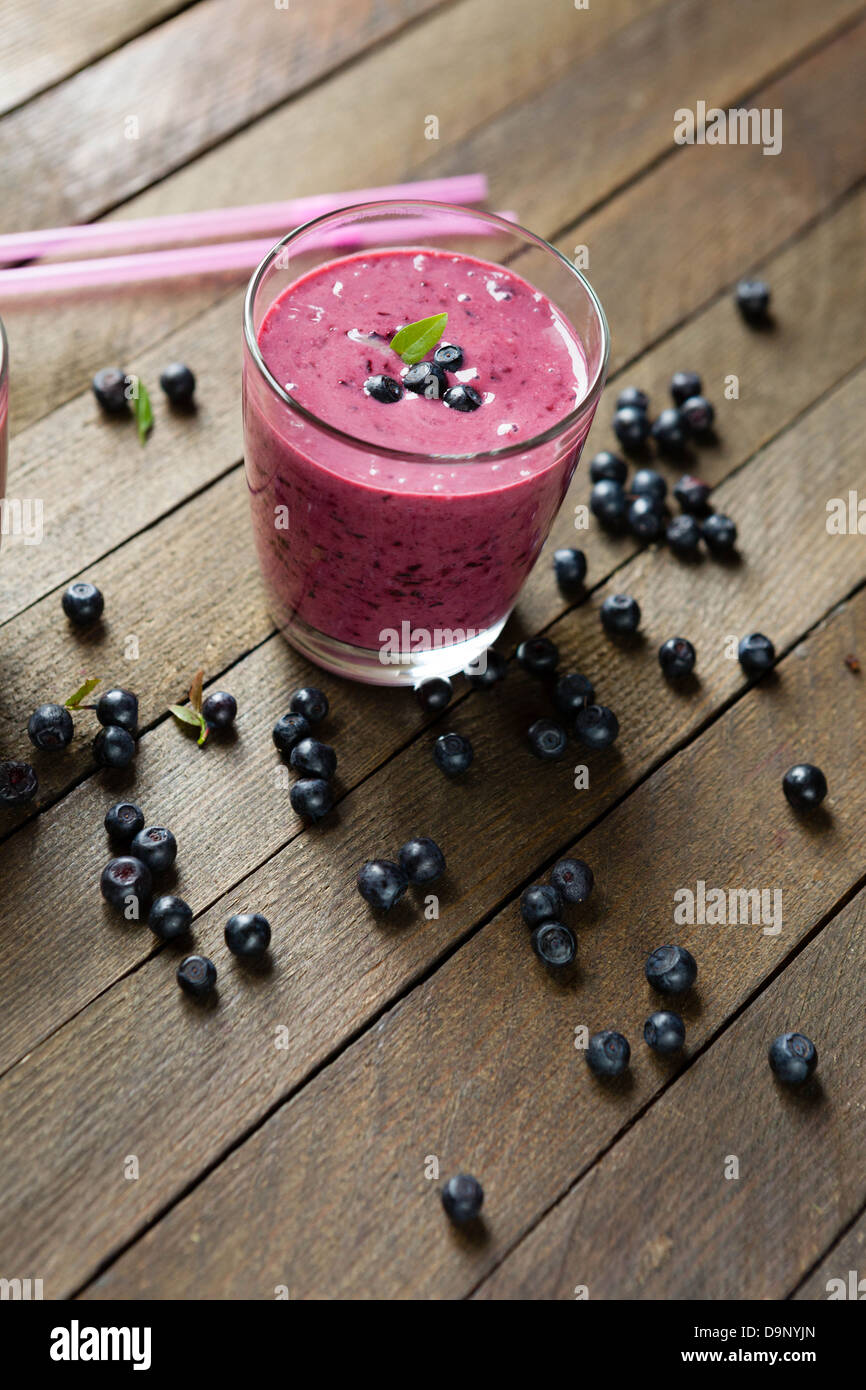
<box><xmin>76</xmin><ymin>583</ymin><xmax>866</xmax><ymax>1298</ymax></box>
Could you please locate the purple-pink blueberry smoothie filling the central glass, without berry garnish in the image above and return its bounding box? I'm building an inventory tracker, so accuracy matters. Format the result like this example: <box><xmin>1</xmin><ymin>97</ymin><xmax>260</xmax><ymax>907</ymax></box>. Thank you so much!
<box><xmin>245</xmin><ymin>247</ymin><xmax>589</xmax><ymax>667</ymax></box>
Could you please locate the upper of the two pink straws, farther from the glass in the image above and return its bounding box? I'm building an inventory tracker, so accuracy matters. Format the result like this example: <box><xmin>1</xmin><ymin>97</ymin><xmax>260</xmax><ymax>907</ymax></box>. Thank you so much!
<box><xmin>0</xmin><ymin>174</ymin><xmax>488</xmax><ymax>265</ymax></box>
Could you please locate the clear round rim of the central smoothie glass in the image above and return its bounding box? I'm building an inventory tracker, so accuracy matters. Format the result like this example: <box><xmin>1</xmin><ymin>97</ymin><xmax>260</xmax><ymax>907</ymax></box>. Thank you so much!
<box><xmin>243</xmin><ymin>199</ymin><xmax>610</xmax><ymax>464</ymax></box>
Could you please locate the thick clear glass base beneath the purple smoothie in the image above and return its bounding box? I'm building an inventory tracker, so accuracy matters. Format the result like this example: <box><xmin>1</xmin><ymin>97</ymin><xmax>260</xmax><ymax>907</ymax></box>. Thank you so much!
<box><xmin>282</xmin><ymin>613</ymin><xmax>510</xmax><ymax>688</ymax></box>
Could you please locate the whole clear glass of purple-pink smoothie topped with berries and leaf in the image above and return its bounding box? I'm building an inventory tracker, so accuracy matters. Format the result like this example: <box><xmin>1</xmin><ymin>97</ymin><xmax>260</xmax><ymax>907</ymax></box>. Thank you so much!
<box><xmin>243</xmin><ymin>203</ymin><xmax>607</xmax><ymax>684</ymax></box>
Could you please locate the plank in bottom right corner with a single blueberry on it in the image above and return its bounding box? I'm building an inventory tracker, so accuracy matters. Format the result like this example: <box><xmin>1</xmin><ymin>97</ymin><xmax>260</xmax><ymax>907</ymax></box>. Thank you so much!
<box><xmin>478</xmin><ymin>889</ymin><xmax>866</xmax><ymax>1300</ymax></box>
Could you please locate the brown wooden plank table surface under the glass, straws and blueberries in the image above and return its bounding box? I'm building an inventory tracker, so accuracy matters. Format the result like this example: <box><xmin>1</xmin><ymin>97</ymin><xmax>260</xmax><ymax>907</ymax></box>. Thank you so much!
<box><xmin>0</xmin><ymin>0</ymin><xmax>866</xmax><ymax>1300</ymax></box>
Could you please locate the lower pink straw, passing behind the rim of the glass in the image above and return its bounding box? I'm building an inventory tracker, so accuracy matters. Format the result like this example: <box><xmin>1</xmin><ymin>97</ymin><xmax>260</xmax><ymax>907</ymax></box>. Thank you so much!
<box><xmin>0</xmin><ymin>211</ymin><xmax>517</xmax><ymax>300</ymax></box>
